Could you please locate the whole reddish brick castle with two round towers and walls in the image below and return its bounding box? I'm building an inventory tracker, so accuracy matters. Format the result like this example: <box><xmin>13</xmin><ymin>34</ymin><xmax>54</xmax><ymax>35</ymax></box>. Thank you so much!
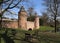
<box><xmin>2</xmin><ymin>6</ymin><xmax>39</xmax><ymax>30</ymax></box>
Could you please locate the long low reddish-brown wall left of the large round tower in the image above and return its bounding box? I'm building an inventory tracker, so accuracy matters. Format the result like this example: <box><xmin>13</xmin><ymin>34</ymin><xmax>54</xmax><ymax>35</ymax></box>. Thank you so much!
<box><xmin>2</xmin><ymin>21</ymin><xmax>18</xmax><ymax>28</ymax></box>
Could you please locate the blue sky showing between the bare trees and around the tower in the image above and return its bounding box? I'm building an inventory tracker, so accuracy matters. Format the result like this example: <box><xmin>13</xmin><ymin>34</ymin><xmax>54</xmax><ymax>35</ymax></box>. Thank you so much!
<box><xmin>4</xmin><ymin>0</ymin><xmax>46</xmax><ymax>18</ymax></box>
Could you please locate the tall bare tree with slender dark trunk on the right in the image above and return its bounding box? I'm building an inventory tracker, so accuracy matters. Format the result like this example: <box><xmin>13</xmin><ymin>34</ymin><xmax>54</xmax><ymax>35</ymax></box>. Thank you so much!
<box><xmin>44</xmin><ymin>0</ymin><xmax>60</xmax><ymax>32</ymax></box>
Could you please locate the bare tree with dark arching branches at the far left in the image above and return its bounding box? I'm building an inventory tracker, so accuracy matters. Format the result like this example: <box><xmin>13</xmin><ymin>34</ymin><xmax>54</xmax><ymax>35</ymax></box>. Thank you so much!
<box><xmin>0</xmin><ymin>0</ymin><xmax>26</xmax><ymax>27</ymax></box>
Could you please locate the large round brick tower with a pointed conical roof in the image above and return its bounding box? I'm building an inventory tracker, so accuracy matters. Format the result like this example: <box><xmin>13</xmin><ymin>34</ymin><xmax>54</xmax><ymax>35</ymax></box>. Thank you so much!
<box><xmin>18</xmin><ymin>6</ymin><xmax>27</xmax><ymax>30</ymax></box>
